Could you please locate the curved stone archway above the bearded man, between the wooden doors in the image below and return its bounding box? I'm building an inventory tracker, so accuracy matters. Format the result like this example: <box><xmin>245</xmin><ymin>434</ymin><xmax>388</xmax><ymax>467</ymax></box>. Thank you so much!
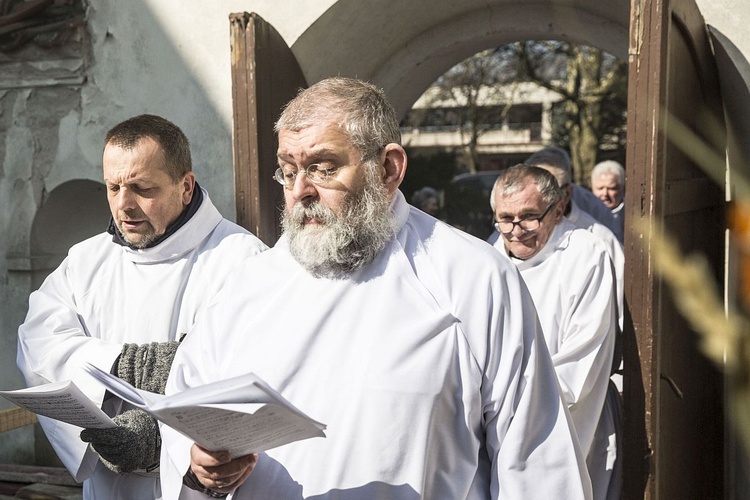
<box><xmin>291</xmin><ymin>0</ymin><xmax>630</xmax><ymax>116</ymax></box>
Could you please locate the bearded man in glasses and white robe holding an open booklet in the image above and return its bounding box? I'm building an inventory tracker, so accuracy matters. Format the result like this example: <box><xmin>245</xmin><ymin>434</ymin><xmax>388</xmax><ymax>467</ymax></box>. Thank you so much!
<box><xmin>162</xmin><ymin>78</ymin><xmax>590</xmax><ymax>500</ymax></box>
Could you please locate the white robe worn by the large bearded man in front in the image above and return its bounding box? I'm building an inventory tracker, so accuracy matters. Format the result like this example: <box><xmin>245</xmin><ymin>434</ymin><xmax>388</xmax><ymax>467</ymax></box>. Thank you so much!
<box><xmin>162</xmin><ymin>192</ymin><xmax>590</xmax><ymax>500</ymax></box>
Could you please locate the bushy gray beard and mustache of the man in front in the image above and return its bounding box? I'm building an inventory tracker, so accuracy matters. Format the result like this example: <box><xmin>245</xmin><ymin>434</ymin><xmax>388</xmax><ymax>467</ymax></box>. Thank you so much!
<box><xmin>281</xmin><ymin>175</ymin><xmax>394</xmax><ymax>279</ymax></box>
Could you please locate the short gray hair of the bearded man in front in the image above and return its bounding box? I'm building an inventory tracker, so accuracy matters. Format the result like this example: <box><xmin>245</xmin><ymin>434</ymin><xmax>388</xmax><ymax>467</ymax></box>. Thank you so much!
<box><xmin>274</xmin><ymin>77</ymin><xmax>401</xmax><ymax>163</ymax></box>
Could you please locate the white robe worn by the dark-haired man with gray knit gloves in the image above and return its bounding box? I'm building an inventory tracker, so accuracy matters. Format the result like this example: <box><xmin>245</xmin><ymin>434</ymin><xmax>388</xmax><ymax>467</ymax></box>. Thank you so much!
<box><xmin>17</xmin><ymin>191</ymin><xmax>266</xmax><ymax>500</ymax></box>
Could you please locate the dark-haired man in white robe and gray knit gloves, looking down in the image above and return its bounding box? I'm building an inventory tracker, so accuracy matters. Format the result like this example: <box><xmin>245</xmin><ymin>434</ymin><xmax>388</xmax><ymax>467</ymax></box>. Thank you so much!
<box><xmin>17</xmin><ymin>115</ymin><xmax>266</xmax><ymax>500</ymax></box>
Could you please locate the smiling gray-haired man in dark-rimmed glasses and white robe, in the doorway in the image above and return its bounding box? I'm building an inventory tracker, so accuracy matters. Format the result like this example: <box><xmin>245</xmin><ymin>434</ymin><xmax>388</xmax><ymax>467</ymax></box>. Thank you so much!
<box><xmin>490</xmin><ymin>164</ymin><xmax>620</xmax><ymax>499</ymax></box>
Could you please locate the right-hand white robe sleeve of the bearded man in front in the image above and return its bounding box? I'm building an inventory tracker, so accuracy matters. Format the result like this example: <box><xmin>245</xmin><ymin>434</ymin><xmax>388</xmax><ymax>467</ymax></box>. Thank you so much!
<box><xmin>483</xmin><ymin>264</ymin><xmax>591</xmax><ymax>499</ymax></box>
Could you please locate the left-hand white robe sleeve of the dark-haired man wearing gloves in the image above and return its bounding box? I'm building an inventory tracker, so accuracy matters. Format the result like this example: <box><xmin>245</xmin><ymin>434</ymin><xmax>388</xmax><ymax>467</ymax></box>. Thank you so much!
<box><xmin>16</xmin><ymin>259</ymin><xmax>122</xmax><ymax>481</ymax></box>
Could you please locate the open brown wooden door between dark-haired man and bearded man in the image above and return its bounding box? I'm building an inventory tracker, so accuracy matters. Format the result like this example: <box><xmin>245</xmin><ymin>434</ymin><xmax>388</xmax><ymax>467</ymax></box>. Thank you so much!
<box><xmin>229</xmin><ymin>12</ymin><xmax>307</xmax><ymax>246</ymax></box>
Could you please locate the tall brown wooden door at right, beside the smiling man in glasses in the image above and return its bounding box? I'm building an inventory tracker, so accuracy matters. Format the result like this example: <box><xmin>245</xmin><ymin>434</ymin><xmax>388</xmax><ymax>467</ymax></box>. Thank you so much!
<box><xmin>623</xmin><ymin>0</ymin><xmax>725</xmax><ymax>499</ymax></box>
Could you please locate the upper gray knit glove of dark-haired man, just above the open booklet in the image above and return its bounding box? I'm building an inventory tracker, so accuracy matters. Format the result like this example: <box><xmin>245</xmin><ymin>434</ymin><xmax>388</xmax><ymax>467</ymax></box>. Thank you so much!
<box><xmin>114</xmin><ymin>340</ymin><xmax>180</xmax><ymax>394</ymax></box>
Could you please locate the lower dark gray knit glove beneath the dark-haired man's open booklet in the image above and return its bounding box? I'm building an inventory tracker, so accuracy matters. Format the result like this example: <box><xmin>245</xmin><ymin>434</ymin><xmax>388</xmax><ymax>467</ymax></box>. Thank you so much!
<box><xmin>81</xmin><ymin>410</ymin><xmax>161</xmax><ymax>474</ymax></box>
